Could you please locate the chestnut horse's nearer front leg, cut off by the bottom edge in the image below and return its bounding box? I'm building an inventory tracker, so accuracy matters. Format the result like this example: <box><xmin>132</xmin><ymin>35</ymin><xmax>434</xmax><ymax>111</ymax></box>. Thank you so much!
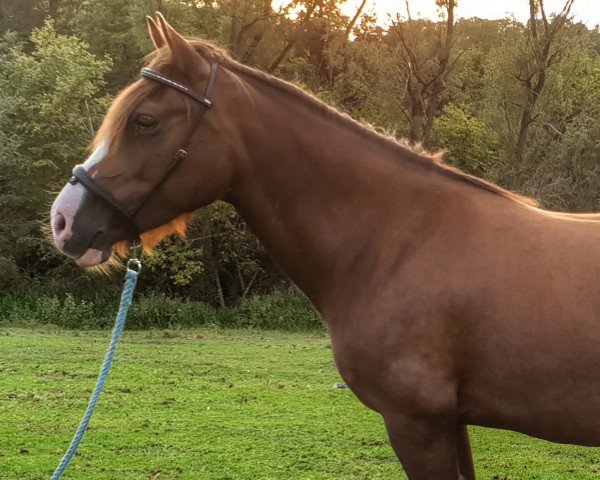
<box><xmin>384</xmin><ymin>414</ymin><xmax>464</xmax><ymax>480</ymax></box>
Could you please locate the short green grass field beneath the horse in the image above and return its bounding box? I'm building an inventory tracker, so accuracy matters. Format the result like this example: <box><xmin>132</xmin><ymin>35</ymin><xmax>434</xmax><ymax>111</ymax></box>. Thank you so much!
<box><xmin>0</xmin><ymin>328</ymin><xmax>600</xmax><ymax>480</ymax></box>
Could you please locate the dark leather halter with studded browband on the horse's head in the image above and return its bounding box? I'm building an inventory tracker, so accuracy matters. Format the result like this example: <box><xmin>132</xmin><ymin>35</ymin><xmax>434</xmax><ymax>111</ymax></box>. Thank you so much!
<box><xmin>69</xmin><ymin>63</ymin><xmax>217</xmax><ymax>240</ymax></box>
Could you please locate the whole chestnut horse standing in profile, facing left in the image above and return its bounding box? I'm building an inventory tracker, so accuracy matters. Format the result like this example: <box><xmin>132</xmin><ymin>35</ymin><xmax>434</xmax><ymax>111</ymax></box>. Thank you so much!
<box><xmin>51</xmin><ymin>15</ymin><xmax>600</xmax><ymax>480</ymax></box>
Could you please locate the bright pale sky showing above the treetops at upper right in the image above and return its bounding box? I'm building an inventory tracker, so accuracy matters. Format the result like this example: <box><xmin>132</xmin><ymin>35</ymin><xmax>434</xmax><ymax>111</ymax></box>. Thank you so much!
<box><xmin>342</xmin><ymin>0</ymin><xmax>600</xmax><ymax>27</ymax></box>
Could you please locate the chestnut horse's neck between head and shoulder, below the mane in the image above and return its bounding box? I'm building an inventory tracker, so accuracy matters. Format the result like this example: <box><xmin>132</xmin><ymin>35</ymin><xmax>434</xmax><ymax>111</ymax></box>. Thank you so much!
<box><xmin>228</xmin><ymin>71</ymin><xmax>446</xmax><ymax>309</ymax></box>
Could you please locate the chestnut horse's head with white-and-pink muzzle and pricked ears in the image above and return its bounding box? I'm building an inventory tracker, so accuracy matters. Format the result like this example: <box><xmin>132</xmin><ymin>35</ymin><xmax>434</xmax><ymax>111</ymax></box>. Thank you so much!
<box><xmin>51</xmin><ymin>14</ymin><xmax>239</xmax><ymax>267</ymax></box>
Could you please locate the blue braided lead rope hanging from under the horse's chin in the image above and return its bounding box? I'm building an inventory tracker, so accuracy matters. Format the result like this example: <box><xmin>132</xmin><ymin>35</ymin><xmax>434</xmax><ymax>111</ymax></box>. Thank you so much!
<box><xmin>51</xmin><ymin>258</ymin><xmax>142</xmax><ymax>480</ymax></box>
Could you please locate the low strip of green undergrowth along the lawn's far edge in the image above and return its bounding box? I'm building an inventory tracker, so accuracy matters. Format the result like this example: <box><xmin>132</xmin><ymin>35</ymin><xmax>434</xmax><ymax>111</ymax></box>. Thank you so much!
<box><xmin>0</xmin><ymin>290</ymin><xmax>323</xmax><ymax>331</ymax></box>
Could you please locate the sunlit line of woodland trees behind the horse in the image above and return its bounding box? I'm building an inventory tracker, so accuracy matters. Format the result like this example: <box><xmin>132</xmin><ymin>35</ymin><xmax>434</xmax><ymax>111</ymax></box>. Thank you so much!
<box><xmin>0</xmin><ymin>0</ymin><xmax>600</xmax><ymax>306</ymax></box>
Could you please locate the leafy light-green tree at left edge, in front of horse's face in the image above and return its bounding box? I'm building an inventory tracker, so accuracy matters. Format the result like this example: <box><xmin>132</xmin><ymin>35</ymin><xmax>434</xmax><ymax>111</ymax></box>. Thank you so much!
<box><xmin>0</xmin><ymin>21</ymin><xmax>111</xmax><ymax>274</ymax></box>
